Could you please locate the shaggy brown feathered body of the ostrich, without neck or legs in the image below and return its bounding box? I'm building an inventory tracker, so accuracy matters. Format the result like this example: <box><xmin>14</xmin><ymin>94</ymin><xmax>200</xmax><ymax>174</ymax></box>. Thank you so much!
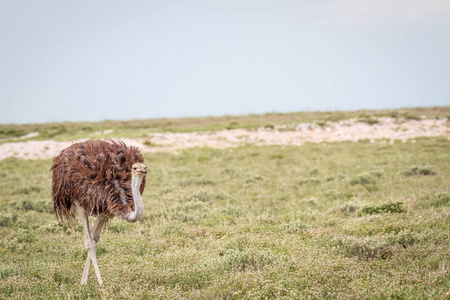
<box><xmin>51</xmin><ymin>140</ymin><xmax>145</xmax><ymax>222</ymax></box>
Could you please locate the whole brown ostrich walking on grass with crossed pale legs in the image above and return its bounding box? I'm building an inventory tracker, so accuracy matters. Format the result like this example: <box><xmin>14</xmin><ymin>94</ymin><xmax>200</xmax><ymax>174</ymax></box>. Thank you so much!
<box><xmin>51</xmin><ymin>140</ymin><xmax>147</xmax><ymax>285</ymax></box>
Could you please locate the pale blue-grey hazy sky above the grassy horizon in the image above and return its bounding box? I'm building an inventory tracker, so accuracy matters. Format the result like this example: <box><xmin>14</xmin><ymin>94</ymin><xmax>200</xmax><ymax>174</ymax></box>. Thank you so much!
<box><xmin>0</xmin><ymin>0</ymin><xmax>450</xmax><ymax>124</ymax></box>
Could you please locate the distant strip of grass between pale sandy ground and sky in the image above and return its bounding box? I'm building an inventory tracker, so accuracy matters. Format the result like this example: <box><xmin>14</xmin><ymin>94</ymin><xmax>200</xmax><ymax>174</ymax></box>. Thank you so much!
<box><xmin>0</xmin><ymin>107</ymin><xmax>450</xmax><ymax>142</ymax></box>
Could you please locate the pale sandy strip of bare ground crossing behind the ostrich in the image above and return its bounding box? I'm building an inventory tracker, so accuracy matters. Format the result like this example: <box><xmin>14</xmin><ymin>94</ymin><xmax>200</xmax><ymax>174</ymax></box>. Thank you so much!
<box><xmin>0</xmin><ymin>118</ymin><xmax>450</xmax><ymax>160</ymax></box>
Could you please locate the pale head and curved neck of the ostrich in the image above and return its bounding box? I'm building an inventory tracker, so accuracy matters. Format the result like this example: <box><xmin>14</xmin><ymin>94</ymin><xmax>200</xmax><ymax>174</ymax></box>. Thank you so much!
<box><xmin>120</xmin><ymin>163</ymin><xmax>147</xmax><ymax>222</ymax></box>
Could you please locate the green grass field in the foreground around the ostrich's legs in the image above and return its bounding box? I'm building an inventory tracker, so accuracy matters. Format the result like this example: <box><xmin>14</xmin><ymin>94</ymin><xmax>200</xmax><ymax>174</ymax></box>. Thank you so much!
<box><xmin>0</xmin><ymin>109</ymin><xmax>450</xmax><ymax>299</ymax></box>
